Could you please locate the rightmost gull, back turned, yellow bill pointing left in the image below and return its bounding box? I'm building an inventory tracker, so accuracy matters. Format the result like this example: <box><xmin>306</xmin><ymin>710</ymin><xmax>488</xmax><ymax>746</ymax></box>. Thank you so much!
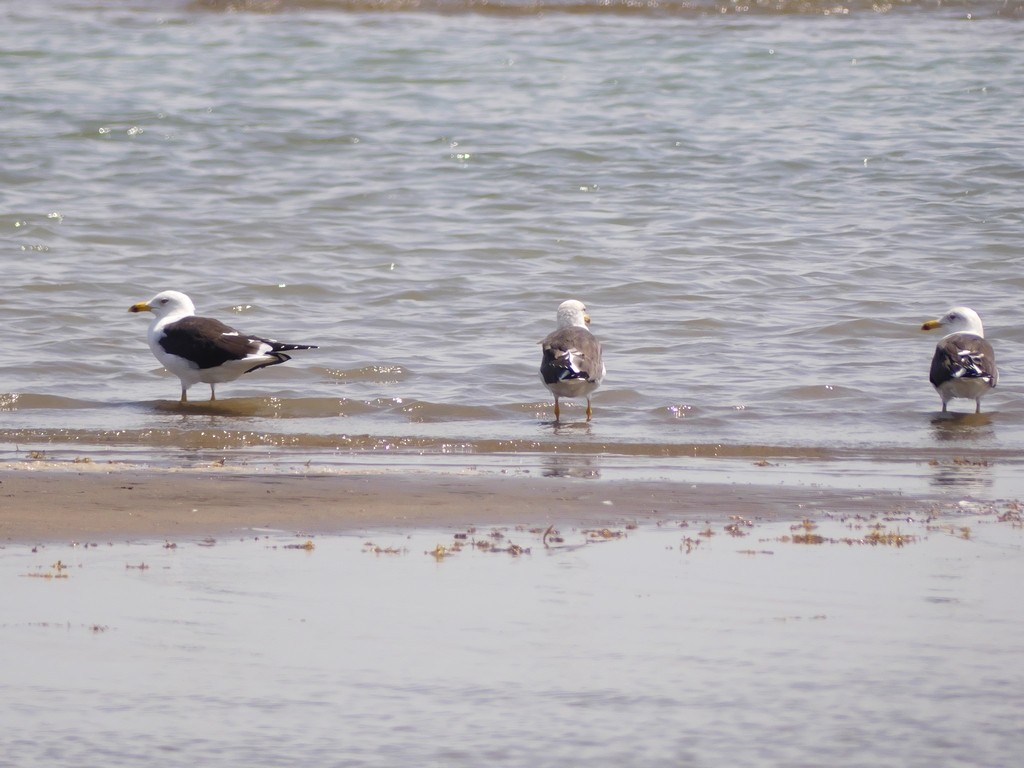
<box><xmin>921</xmin><ymin>306</ymin><xmax>999</xmax><ymax>414</ymax></box>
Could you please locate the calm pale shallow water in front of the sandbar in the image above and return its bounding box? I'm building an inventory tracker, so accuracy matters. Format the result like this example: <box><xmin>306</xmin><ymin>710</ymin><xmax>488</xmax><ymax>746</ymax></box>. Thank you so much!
<box><xmin>0</xmin><ymin>506</ymin><xmax>1024</xmax><ymax>768</ymax></box>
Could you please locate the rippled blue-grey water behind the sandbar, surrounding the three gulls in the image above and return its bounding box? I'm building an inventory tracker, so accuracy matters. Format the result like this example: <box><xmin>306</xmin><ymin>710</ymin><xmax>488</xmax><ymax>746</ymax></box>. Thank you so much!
<box><xmin>0</xmin><ymin>2</ymin><xmax>1024</xmax><ymax>487</ymax></box>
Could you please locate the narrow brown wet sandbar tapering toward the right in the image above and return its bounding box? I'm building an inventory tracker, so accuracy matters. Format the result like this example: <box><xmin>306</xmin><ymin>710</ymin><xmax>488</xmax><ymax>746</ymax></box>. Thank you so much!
<box><xmin>0</xmin><ymin>469</ymin><xmax>935</xmax><ymax>543</ymax></box>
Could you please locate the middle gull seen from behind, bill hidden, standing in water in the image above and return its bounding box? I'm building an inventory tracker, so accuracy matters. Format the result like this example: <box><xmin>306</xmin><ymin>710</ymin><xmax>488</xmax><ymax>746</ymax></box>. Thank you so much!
<box><xmin>541</xmin><ymin>299</ymin><xmax>604</xmax><ymax>422</ymax></box>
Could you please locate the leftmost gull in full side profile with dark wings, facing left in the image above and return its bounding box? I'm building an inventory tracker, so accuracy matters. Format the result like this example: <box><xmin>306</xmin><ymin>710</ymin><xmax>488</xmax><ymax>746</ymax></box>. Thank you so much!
<box><xmin>128</xmin><ymin>291</ymin><xmax>316</xmax><ymax>402</ymax></box>
